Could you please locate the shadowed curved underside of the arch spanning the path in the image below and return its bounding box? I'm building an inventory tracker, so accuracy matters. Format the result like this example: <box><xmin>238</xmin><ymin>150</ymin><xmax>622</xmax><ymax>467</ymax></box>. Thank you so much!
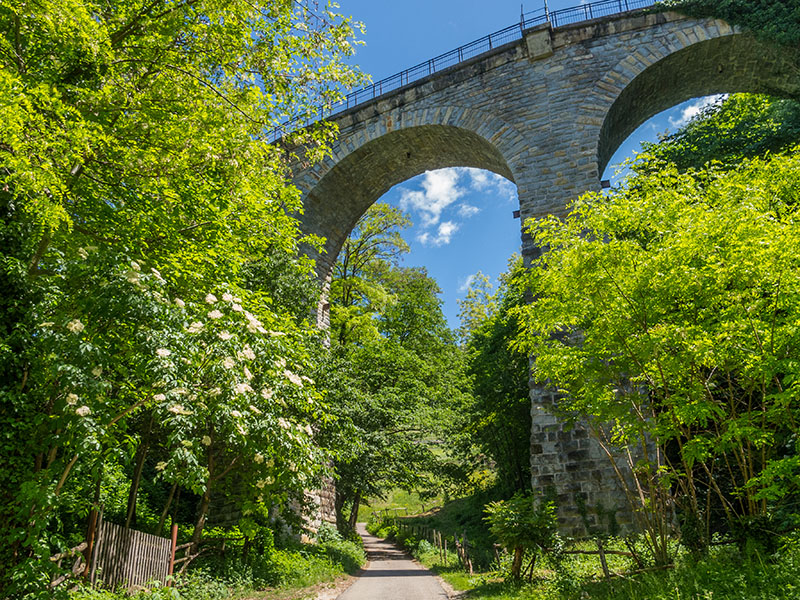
<box><xmin>302</xmin><ymin>125</ymin><xmax>514</xmax><ymax>279</ymax></box>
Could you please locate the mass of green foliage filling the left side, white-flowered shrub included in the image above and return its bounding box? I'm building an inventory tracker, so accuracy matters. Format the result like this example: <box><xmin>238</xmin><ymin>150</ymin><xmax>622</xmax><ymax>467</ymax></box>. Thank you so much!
<box><xmin>0</xmin><ymin>0</ymin><xmax>366</xmax><ymax>597</ymax></box>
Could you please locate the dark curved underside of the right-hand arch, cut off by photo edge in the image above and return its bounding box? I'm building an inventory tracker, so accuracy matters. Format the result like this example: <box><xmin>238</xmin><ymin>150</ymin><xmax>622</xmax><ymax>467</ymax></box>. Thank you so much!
<box><xmin>598</xmin><ymin>34</ymin><xmax>800</xmax><ymax>173</ymax></box>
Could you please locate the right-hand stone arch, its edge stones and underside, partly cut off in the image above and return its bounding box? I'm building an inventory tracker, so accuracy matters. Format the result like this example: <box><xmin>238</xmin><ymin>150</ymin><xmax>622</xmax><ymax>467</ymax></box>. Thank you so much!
<box><xmin>592</xmin><ymin>20</ymin><xmax>800</xmax><ymax>173</ymax></box>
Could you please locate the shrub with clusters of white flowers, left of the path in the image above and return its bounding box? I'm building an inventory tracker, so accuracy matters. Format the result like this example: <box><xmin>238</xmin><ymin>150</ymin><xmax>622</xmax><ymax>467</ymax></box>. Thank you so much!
<box><xmin>9</xmin><ymin>248</ymin><xmax>328</xmax><ymax>552</ymax></box>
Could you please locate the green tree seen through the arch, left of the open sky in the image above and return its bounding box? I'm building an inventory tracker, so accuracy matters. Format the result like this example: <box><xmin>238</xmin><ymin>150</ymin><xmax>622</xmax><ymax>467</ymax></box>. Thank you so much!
<box><xmin>318</xmin><ymin>204</ymin><xmax>464</xmax><ymax>525</ymax></box>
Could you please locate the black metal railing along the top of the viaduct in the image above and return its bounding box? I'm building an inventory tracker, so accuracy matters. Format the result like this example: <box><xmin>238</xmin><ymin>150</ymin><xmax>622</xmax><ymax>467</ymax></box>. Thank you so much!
<box><xmin>269</xmin><ymin>0</ymin><xmax>656</xmax><ymax>141</ymax></box>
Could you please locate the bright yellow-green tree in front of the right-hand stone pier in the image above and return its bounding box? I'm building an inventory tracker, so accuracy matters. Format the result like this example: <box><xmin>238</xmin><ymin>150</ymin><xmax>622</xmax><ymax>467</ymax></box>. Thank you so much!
<box><xmin>519</xmin><ymin>151</ymin><xmax>800</xmax><ymax>559</ymax></box>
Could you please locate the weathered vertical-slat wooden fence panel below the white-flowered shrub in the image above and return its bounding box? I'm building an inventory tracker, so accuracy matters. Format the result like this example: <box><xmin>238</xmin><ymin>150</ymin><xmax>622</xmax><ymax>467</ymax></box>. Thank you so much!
<box><xmin>89</xmin><ymin>517</ymin><xmax>174</xmax><ymax>590</ymax></box>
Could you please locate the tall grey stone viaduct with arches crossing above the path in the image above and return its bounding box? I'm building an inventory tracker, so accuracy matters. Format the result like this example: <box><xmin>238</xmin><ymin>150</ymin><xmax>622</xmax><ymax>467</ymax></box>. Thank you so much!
<box><xmin>294</xmin><ymin>5</ymin><xmax>800</xmax><ymax>533</ymax></box>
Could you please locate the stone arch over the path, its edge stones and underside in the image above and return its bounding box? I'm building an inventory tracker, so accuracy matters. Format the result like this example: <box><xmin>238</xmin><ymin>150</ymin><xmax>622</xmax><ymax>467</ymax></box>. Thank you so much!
<box><xmin>296</xmin><ymin>108</ymin><xmax>525</xmax><ymax>281</ymax></box>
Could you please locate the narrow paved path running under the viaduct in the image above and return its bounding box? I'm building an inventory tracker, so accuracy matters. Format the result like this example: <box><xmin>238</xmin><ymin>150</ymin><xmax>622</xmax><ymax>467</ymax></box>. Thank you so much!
<box><xmin>337</xmin><ymin>523</ymin><xmax>447</xmax><ymax>600</ymax></box>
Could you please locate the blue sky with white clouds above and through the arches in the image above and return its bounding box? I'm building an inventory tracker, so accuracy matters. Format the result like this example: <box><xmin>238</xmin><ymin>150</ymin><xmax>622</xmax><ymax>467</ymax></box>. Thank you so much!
<box><xmin>338</xmin><ymin>0</ymin><xmax>713</xmax><ymax>327</ymax></box>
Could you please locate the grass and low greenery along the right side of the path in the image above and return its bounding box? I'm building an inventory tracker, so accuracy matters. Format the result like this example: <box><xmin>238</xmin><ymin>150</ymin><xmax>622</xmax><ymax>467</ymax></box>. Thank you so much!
<box><xmin>372</xmin><ymin>494</ymin><xmax>800</xmax><ymax>600</ymax></box>
